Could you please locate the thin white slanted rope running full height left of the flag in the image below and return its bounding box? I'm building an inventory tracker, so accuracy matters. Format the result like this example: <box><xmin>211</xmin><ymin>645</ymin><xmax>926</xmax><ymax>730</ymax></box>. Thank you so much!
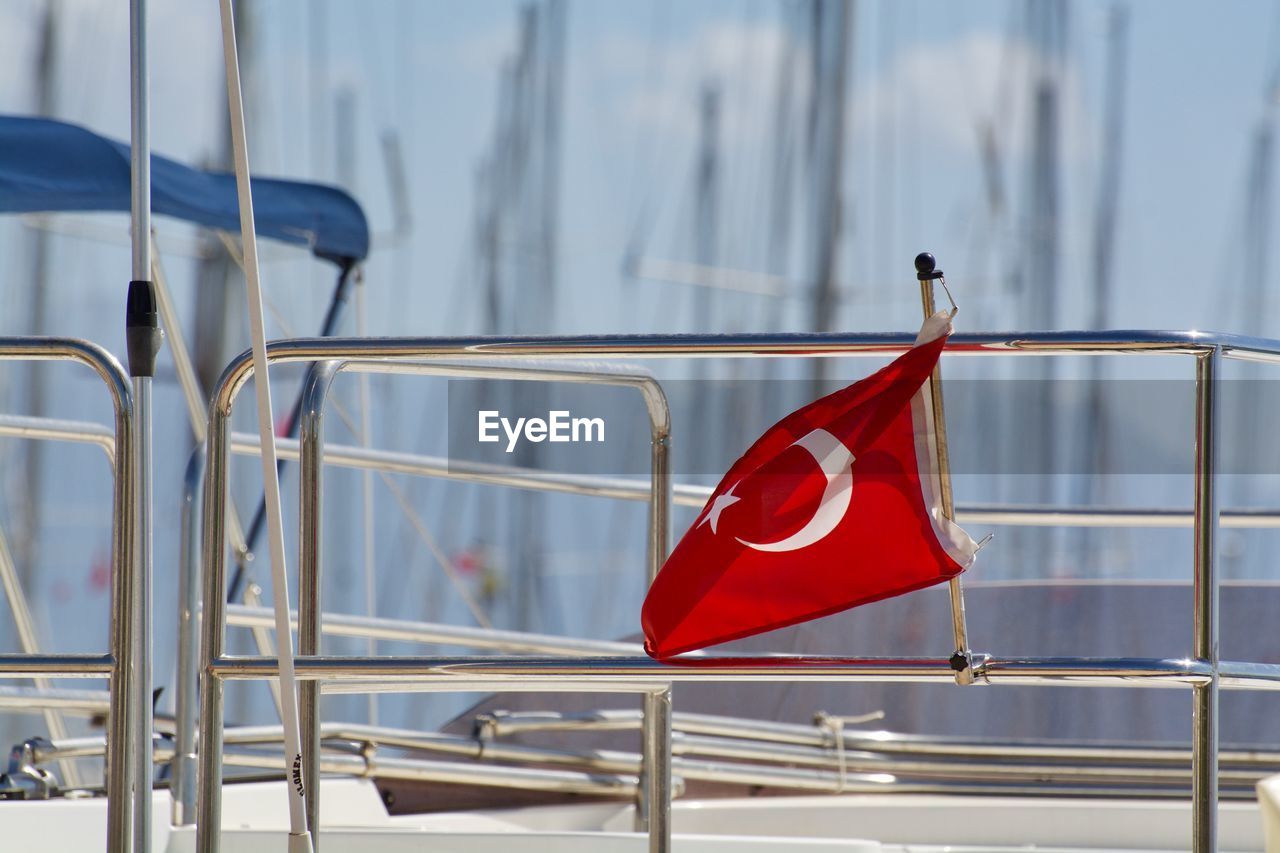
<box><xmin>219</xmin><ymin>0</ymin><xmax>312</xmax><ymax>853</ymax></box>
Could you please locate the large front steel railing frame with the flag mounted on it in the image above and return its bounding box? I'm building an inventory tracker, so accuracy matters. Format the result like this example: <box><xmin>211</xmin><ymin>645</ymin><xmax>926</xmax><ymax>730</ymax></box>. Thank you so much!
<box><xmin>185</xmin><ymin>332</ymin><xmax>1280</xmax><ymax>852</ymax></box>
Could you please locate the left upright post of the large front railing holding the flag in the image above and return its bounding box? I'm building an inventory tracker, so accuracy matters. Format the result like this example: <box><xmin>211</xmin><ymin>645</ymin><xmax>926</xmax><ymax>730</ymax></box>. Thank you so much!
<box><xmin>196</xmin><ymin>394</ymin><xmax>230</xmax><ymax>853</ymax></box>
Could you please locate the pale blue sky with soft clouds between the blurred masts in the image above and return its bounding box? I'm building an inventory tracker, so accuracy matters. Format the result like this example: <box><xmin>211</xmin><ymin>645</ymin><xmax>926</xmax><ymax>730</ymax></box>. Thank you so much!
<box><xmin>0</xmin><ymin>0</ymin><xmax>1280</xmax><ymax>732</ymax></box>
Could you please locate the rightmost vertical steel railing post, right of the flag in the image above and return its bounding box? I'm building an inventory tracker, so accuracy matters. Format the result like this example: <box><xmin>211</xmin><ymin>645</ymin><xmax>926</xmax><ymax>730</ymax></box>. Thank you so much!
<box><xmin>1192</xmin><ymin>347</ymin><xmax>1222</xmax><ymax>853</ymax></box>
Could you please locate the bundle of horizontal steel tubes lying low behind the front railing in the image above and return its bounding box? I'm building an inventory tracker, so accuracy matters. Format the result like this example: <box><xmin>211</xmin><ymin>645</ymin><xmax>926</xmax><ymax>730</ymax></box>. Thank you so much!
<box><xmin>194</xmin><ymin>712</ymin><xmax>1280</xmax><ymax>797</ymax></box>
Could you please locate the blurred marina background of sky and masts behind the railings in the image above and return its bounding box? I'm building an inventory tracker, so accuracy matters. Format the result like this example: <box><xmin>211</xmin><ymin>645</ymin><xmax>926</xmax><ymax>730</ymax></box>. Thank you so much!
<box><xmin>0</xmin><ymin>0</ymin><xmax>1280</xmax><ymax>742</ymax></box>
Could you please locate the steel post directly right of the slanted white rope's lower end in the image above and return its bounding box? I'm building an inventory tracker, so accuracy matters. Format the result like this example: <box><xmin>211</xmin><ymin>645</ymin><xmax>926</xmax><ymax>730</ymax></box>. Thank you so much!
<box><xmin>298</xmin><ymin>361</ymin><xmax>340</xmax><ymax>850</ymax></box>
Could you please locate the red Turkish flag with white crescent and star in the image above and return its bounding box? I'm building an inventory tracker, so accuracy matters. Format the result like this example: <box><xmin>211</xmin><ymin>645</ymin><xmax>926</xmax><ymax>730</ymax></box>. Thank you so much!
<box><xmin>640</xmin><ymin>313</ymin><xmax>977</xmax><ymax>658</ymax></box>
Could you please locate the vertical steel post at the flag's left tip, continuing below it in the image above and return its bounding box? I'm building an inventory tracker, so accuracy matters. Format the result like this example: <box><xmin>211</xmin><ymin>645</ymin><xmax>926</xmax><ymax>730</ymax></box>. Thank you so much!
<box><xmin>636</xmin><ymin>414</ymin><xmax>672</xmax><ymax>853</ymax></box>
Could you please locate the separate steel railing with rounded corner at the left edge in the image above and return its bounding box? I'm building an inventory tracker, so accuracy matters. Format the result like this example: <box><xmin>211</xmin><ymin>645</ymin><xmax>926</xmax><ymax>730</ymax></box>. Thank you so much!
<box><xmin>0</xmin><ymin>338</ymin><xmax>140</xmax><ymax>853</ymax></box>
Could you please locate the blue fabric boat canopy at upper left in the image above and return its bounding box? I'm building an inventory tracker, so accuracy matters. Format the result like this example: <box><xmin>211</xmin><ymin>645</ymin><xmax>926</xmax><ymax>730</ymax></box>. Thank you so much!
<box><xmin>0</xmin><ymin>115</ymin><xmax>369</xmax><ymax>266</ymax></box>
